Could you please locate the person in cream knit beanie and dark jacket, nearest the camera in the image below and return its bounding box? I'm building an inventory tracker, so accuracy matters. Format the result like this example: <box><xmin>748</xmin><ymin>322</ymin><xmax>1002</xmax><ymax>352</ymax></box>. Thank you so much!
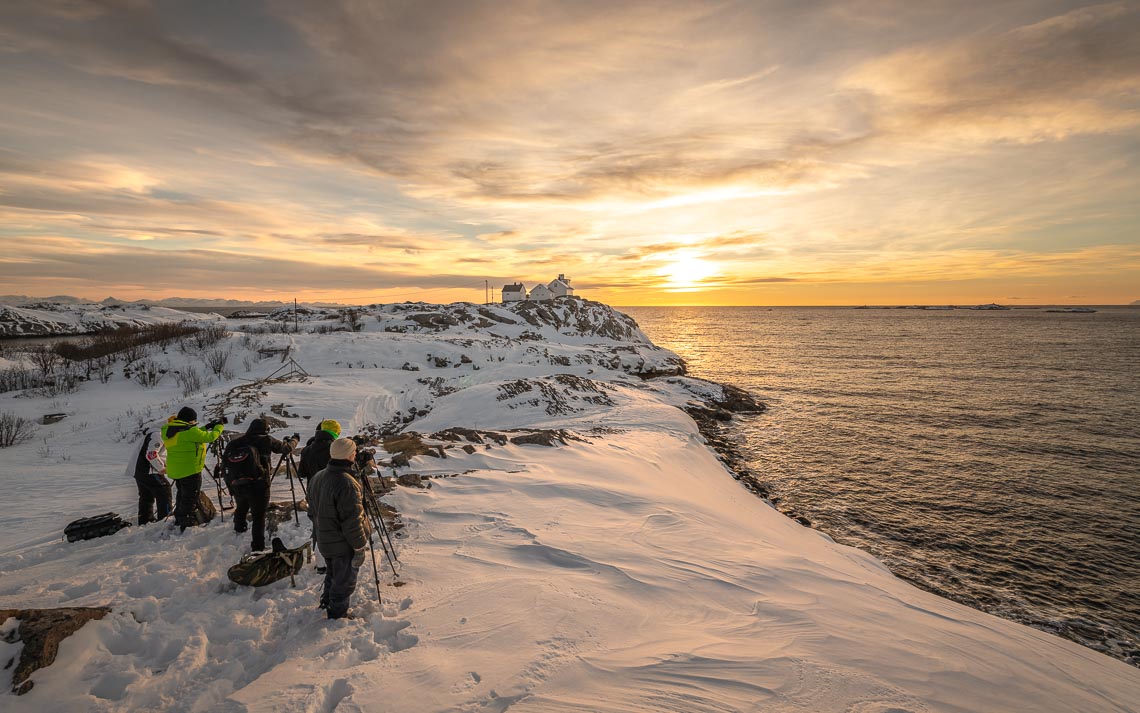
<box><xmin>309</xmin><ymin>438</ymin><xmax>371</xmax><ymax>619</ymax></box>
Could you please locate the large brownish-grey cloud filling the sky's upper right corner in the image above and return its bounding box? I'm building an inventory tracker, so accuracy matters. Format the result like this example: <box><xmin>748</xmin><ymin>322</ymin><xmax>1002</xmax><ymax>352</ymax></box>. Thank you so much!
<box><xmin>842</xmin><ymin>2</ymin><xmax>1140</xmax><ymax>143</ymax></box>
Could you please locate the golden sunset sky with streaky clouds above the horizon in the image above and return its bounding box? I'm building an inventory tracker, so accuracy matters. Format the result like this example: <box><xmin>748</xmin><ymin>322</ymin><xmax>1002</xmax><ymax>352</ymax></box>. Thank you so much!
<box><xmin>0</xmin><ymin>0</ymin><xmax>1140</xmax><ymax>306</ymax></box>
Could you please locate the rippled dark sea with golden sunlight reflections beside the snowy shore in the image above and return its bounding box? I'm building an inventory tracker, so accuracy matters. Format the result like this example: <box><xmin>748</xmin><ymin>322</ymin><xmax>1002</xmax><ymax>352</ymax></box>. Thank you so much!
<box><xmin>620</xmin><ymin>307</ymin><xmax>1140</xmax><ymax>666</ymax></box>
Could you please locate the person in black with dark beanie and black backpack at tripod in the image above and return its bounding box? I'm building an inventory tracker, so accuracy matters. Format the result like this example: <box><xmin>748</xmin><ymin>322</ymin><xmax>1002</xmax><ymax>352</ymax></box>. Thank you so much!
<box><xmin>222</xmin><ymin>419</ymin><xmax>301</xmax><ymax>552</ymax></box>
